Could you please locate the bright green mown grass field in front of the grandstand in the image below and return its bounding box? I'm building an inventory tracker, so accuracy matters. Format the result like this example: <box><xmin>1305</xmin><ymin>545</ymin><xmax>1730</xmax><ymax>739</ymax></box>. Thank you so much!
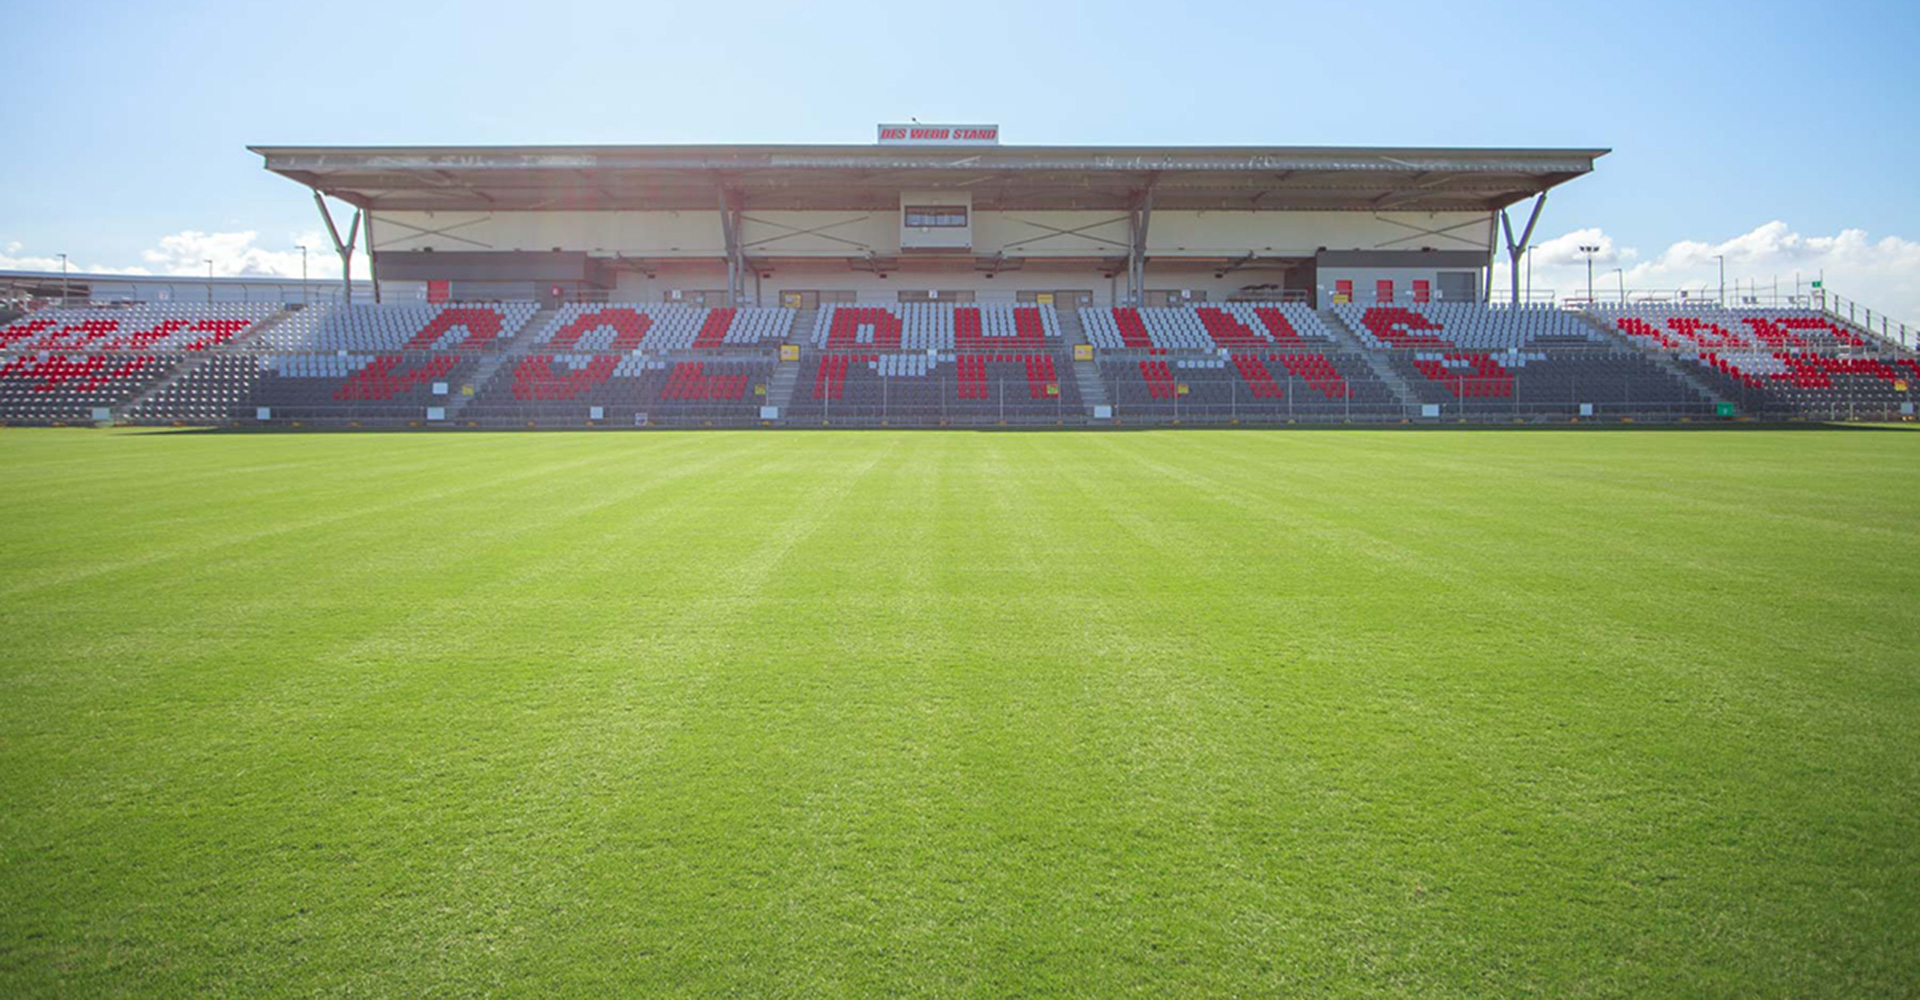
<box><xmin>0</xmin><ymin>430</ymin><xmax>1920</xmax><ymax>998</ymax></box>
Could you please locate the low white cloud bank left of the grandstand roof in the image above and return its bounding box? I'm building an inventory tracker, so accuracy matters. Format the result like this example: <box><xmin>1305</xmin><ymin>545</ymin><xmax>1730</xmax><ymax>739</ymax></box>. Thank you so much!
<box><xmin>0</xmin><ymin>230</ymin><xmax>347</xmax><ymax>280</ymax></box>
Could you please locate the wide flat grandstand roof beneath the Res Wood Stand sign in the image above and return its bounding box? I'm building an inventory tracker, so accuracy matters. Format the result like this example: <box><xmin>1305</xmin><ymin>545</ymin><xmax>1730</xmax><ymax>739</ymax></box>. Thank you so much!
<box><xmin>250</xmin><ymin>146</ymin><xmax>1609</xmax><ymax>211</ymax></box>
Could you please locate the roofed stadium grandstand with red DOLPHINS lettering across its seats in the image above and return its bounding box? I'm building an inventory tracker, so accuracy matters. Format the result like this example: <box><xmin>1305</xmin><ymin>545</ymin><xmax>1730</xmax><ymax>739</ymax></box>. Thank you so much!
<box><xmin>0</xmin><ymin>127</ymin><xmax>1920</xmax><ymax>428</ymax></box>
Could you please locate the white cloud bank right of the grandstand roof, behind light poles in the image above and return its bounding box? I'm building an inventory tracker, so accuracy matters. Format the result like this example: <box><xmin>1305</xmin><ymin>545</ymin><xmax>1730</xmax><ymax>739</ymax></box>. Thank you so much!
<box><xmin>1494</xmin><ymin>221</ymin><xmax>1920</xmax><ymax>326</ymax></box>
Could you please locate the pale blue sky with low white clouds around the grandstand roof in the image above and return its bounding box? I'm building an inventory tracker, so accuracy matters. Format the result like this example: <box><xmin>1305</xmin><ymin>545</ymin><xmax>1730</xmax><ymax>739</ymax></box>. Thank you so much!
<box><xmin>0</xmin><ymin>0</ymin><xmax>1920</xmax><ymax>321</ymax></box>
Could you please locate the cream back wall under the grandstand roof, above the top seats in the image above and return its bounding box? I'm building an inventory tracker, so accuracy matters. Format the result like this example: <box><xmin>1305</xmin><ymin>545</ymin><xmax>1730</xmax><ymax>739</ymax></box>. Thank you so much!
<box><xmin>362</xmin><ymin>206</ymin><xmax>1494</xmax><ymax>305</ymax></box>
